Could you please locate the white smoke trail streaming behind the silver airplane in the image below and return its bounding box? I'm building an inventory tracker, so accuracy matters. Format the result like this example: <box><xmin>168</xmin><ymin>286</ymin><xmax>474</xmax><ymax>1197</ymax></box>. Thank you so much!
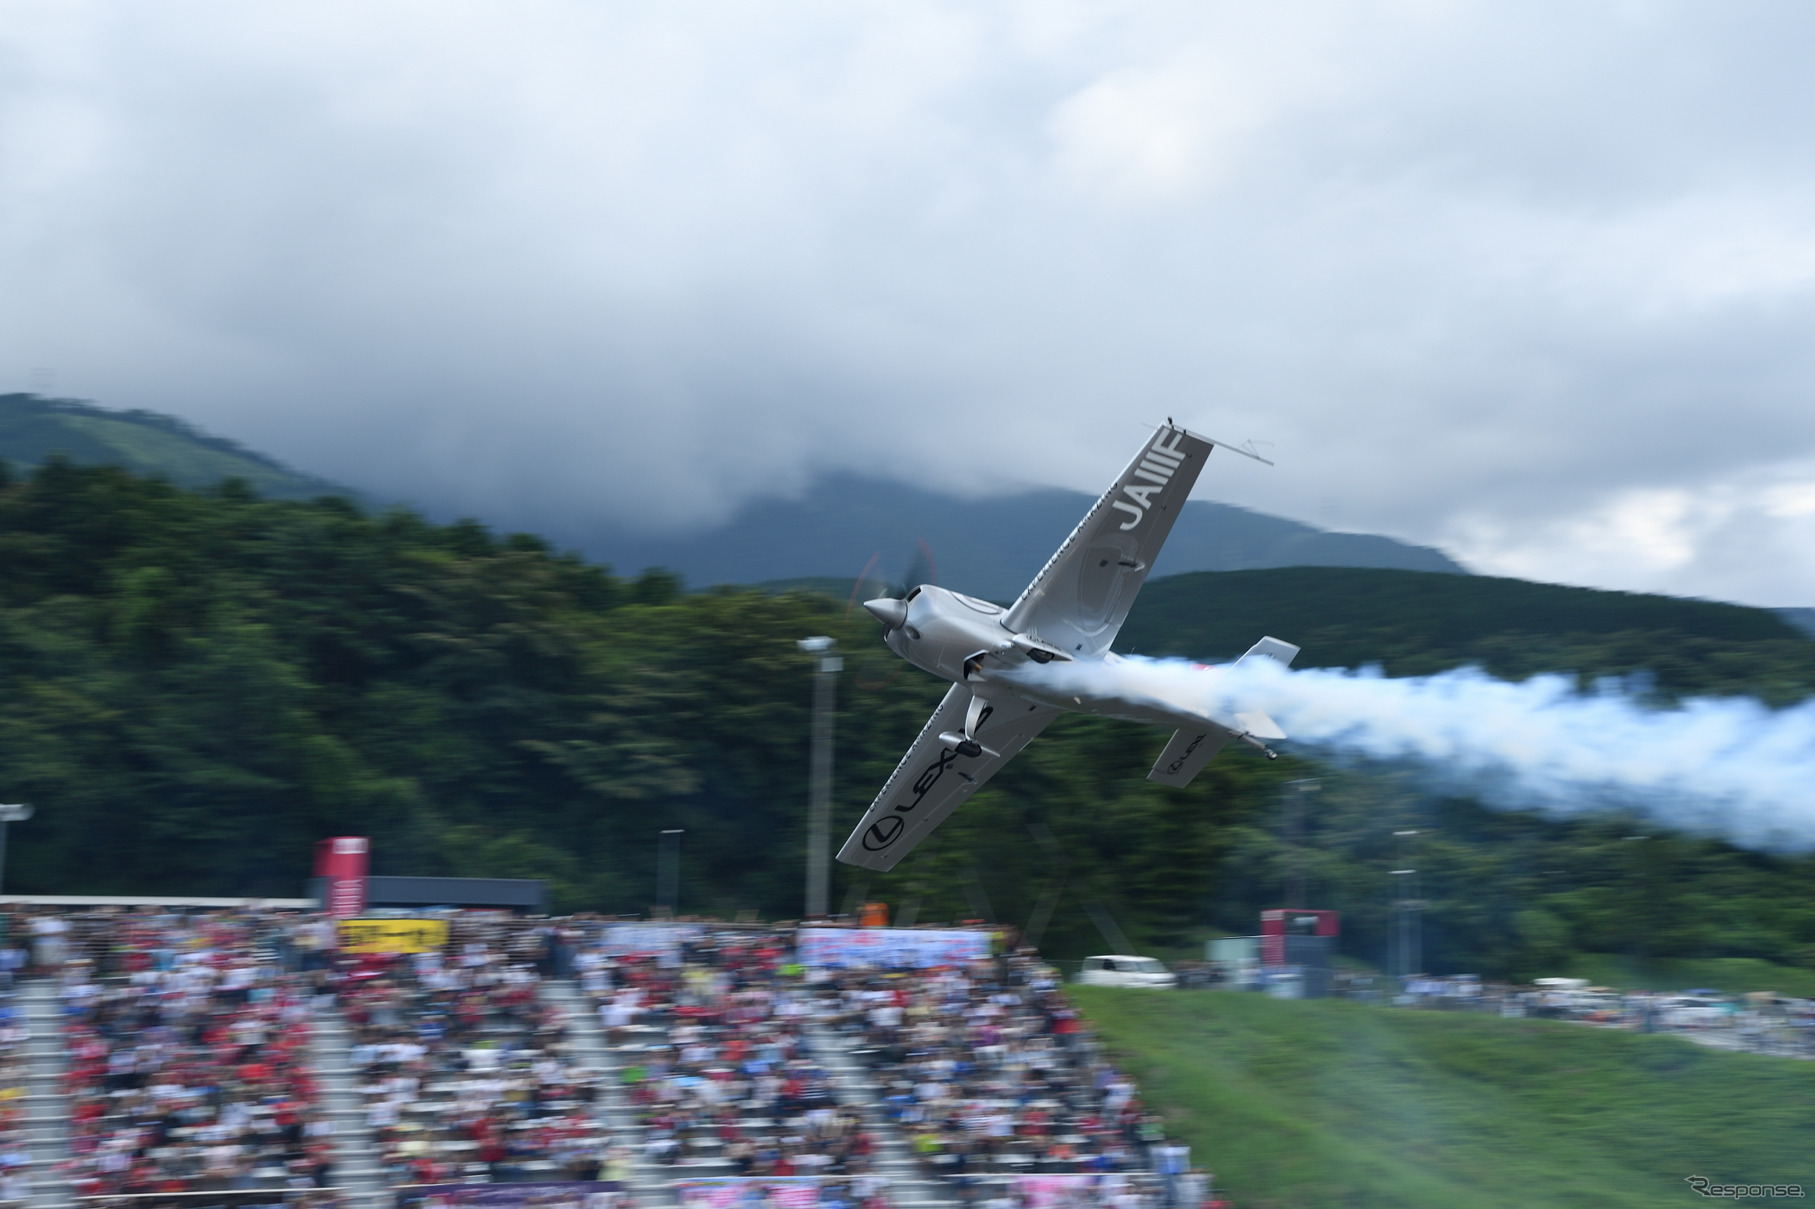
<box><xmin>1001</xmin><ymin>657</ymin><xmax>1815</xmax><ymax>851</ymax></box>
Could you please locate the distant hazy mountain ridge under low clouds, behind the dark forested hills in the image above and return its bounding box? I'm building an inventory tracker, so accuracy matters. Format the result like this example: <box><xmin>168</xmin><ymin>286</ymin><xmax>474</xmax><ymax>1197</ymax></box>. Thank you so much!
<box><xmin>0</xmin><ymin>394</ymin><xmax>1468</xmax><ymax>599</ymax></box>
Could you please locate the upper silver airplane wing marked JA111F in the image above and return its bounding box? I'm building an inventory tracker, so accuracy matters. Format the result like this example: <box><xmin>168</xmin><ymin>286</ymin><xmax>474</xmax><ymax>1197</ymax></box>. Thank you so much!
<box><xmin>1002</xmin><ymin>425</ymin><xmax>1216</xmax><ymax>657</ymax></box>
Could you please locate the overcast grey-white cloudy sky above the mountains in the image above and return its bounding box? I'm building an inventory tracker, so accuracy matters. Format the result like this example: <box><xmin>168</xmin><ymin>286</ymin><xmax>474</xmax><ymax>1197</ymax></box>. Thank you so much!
<box><xmin>0</xmin><ymin>0</ymin><xmax>1815</xmax><ymax>605</ymax></box>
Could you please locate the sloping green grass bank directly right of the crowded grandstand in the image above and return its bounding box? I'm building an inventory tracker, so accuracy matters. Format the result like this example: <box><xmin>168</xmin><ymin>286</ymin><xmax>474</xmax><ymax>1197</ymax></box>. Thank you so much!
<box><xmin>1073</xmin><ymin>988</ymin><xmax>1815</xmax><ymax>1209</ymax></box>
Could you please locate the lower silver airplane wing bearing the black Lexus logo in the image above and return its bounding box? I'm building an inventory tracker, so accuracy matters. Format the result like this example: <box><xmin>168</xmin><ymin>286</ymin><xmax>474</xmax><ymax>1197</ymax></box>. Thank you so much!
<box><xmin>839</xmin><ymin>684</ymin><xmax>1062</xmax><ymax>873</ymax></box>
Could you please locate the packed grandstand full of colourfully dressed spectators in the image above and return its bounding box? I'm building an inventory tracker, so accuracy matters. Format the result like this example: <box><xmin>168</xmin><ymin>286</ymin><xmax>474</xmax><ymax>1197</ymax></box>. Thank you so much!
<box><xmin>0</xmin><ymin>902</ymin><xmax>1196</xmax><ymax>1209</ymax></box>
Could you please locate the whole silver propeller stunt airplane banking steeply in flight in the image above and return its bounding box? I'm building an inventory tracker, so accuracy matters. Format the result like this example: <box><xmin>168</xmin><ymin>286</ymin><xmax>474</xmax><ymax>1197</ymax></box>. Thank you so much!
<box><xmin>839</xmin><ymin>419</ymin><xmax>1298</xmax><ymax>873</ymax></box>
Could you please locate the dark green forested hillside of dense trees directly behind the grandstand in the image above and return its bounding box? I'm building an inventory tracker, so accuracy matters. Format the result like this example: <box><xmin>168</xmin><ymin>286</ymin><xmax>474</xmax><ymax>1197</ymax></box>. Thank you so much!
<box><xmin>0</xmin><ymin>461</ymin><xmax>1815</xmax><ymax>973</ymax></box>
